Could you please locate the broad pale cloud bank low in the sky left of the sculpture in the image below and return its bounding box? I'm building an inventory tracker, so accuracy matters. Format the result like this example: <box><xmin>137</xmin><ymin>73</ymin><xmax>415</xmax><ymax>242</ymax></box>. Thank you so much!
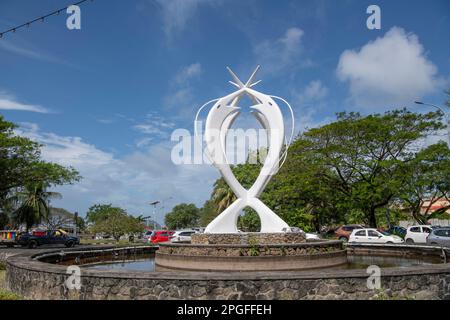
<box><xmin>17</xmin><ymin>123</ymin><xmax>218</xmax><ymax>222</ymax></box>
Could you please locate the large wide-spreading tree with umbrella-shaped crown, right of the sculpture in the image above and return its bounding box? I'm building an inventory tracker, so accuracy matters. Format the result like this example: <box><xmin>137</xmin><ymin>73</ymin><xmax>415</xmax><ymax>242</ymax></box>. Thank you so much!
<box><xmin>300</xmin><ymin>109</ymin><xmax>443</xmax><ymax>227</ymax></box>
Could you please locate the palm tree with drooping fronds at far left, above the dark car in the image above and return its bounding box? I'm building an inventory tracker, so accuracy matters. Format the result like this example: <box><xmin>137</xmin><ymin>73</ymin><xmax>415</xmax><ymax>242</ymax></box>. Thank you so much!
<box><xmin>13</xmin><ymin>183</ymin><xmax>61</xmax><ymax>232</ymax></box>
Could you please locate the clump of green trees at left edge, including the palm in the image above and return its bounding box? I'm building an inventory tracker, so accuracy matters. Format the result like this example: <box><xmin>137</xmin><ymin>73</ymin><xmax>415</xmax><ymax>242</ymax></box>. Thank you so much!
<box><xmin>0</xmin><ymin>115</ymin><xmax>81</xmax><ymax>228</ymax></box>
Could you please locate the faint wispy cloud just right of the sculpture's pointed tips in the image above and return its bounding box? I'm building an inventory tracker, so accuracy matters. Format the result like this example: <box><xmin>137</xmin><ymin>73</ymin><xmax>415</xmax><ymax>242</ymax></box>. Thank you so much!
<box><xmin>253</xmin><ymin>27</ymin><xmax>304</xmax><ymax>73</ymax></box>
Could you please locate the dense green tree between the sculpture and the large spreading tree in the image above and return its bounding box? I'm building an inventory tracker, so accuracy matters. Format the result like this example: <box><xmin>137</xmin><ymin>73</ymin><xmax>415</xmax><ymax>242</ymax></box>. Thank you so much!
<box><xmin>261</xmin><ymin>137</ymin><xmax>345</xmax><ymax>231</ymax></box>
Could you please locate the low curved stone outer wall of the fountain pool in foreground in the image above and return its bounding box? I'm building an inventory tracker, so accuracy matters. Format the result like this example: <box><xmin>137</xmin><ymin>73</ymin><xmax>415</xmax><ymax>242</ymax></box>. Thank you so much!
<box><xmin>7</xmin><ymin>258</ymin><xmax>450</xmax><ymax>300</ymax></box>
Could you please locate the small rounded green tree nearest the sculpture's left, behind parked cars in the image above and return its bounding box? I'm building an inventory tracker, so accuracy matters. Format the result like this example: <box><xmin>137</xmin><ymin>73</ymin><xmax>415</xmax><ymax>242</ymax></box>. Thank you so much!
<box><xmin>164</xmin><ymin>203</ymin><xmax>200</xmax><ymax>229</ymax></box>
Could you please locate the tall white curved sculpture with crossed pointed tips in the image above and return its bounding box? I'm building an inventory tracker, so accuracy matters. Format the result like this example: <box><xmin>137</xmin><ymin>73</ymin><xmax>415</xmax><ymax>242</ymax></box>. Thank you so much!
<box><xmin>196</xmin><ymin>66</ymin><xmax>294</xmax><ymax>233</ymax></box>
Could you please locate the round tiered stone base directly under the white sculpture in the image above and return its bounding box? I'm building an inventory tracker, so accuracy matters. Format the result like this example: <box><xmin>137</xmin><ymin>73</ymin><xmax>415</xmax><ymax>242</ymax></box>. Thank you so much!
<box><xmin>155</xmin><ymin>232</ymin><xmax>347</xmax><ymax>271</ymax></box>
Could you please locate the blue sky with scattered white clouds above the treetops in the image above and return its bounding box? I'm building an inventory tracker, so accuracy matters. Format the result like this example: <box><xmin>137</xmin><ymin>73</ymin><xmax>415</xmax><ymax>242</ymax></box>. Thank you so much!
<box><xmin>0</xmin><ymin>0</ymin><xmax>450</xmax><ymax>221</ymax></box>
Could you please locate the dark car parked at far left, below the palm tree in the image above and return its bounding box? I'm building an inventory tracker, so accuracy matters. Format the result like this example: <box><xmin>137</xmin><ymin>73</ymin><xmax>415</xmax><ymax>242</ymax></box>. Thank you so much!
<box><xmin>17</xmin><ymin>229</ymin><xmax>80</xmax><ymax>248</ymax></box>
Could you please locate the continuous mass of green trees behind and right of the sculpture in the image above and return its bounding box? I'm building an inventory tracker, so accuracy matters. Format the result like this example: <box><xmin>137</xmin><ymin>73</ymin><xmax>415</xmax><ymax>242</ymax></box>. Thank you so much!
<box><xmin>196</xmin><ymin>109</ymin><xmax>450</xmax><ymax>231</ymax></box>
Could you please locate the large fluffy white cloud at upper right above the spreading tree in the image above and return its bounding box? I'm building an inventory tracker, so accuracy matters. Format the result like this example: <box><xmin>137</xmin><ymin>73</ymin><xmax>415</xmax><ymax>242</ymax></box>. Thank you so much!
<box><xmin>337</xmin><ymin>27</ymin><xmax>443</xmax><ymax>108</ymax></box>
